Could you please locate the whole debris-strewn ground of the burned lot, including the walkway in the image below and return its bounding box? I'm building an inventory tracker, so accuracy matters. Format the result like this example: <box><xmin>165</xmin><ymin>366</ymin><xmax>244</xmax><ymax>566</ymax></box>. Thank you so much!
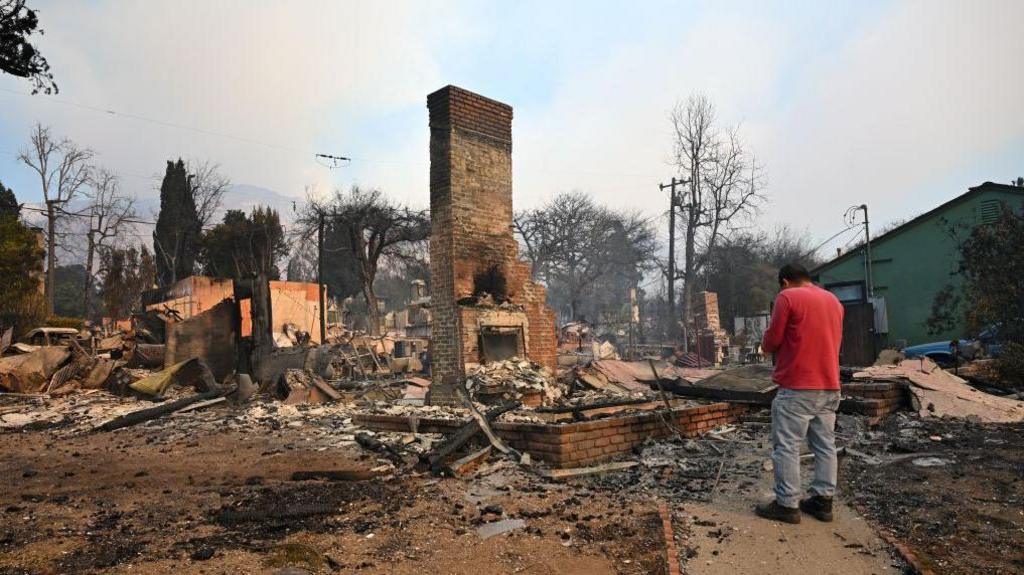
<box><xmin>0</xmin><ymin>331</ymin><xmax>1024</xmax><ymax>575</ymax></box>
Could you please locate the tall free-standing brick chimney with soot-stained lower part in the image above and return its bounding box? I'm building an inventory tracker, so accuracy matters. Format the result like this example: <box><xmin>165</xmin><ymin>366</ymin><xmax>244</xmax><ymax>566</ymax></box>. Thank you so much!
<box><xmin>427</xmin><ymin>86</ymin><xmax>556</xmax><ymax>403</ymax></box>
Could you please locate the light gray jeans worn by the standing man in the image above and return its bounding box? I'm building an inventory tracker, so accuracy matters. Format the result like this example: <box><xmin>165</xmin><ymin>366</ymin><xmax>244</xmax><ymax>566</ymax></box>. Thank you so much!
<box><xmin>771</xmin><ymin>389</ymin><xmax>840</xmax><ymax>507</ymax></box>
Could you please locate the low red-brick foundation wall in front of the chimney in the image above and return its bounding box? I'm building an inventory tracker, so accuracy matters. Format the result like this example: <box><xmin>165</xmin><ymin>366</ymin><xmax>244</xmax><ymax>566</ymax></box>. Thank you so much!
<box><xmin>352</xmin><ymin>403</ymin><xmax>746</xmax><ymax>468</ymax></box>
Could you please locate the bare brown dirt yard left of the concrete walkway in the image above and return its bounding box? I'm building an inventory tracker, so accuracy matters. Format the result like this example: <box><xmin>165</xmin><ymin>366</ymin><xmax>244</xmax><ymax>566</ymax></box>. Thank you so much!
<box><xmin>0</xmin><ymin>412</ymin><xmax>665</xmax><ymax>575</ymax></box>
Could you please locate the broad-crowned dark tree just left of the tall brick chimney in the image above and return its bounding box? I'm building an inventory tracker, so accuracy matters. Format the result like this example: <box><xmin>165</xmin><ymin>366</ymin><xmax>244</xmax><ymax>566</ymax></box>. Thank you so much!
<box><xmin>299</xmin><ymin>186</ymin><xmax>430</xmax><ymax>336</ymax></box>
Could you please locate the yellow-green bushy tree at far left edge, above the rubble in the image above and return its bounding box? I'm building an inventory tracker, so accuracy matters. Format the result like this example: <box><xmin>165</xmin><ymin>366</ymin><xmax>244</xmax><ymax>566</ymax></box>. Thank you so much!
<box><xmin>0</xmin><ymin>214</ymin><xmax>45</xmax><ymax>336</ymax></box>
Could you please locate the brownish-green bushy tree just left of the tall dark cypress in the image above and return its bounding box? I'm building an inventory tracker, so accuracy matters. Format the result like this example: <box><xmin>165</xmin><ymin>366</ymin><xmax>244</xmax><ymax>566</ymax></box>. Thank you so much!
<box><xmin>99</xmin><ymin>246</ymin><xmax>157</xmax><ymax>320</ymax></box>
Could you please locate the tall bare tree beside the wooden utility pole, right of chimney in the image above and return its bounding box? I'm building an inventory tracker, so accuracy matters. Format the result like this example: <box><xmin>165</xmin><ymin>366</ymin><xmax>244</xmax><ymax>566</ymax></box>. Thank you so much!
<box><xmin>670</xmin><ymin>95</ymin><xmax>765</xmax><ymax>348</ymax></box>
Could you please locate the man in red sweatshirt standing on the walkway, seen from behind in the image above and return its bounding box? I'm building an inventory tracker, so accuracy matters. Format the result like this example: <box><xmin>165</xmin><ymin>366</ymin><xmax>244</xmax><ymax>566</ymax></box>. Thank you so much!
<box><xmin>755</xmin><ymin>264</ymin><xmax>843</xmax><ymax>523</ymax></box>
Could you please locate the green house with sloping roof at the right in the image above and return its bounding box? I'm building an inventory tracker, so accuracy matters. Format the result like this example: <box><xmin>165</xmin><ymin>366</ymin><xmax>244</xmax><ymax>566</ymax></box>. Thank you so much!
<box><xmin>811</xmin><ymin>182</ymin><xmax>1024</xmax><ymax>348</ymax></box>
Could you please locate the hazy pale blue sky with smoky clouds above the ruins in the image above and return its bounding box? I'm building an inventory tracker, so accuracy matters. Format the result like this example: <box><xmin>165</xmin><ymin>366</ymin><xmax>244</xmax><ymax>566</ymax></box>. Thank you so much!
<box><xmin>0</xmin><ymin>0</ymin><xmax>1024</xmax><ymax>250</ymax></box>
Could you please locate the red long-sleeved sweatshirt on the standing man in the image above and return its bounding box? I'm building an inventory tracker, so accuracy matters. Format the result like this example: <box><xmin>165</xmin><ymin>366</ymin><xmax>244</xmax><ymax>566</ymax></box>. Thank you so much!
<box><xmin>763</xmin><ymin>284</ymin><xmax>843</xmax><ymax>390</ymax></box>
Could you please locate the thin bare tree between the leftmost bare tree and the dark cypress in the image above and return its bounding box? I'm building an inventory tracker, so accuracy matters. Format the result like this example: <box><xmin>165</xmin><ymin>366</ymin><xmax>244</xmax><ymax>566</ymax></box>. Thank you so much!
<box><xmin>82</xmin><ymin>168</ymin><xmax>136</xmax><ymax>315</ymax></box>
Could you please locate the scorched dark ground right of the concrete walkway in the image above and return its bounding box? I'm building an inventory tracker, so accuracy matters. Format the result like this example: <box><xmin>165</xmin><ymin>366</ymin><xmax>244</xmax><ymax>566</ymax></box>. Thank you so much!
<box><xmin>840</xmin><ymin>413</ymin><xmax>1024</xmax><ymax>575</ymax></box>
